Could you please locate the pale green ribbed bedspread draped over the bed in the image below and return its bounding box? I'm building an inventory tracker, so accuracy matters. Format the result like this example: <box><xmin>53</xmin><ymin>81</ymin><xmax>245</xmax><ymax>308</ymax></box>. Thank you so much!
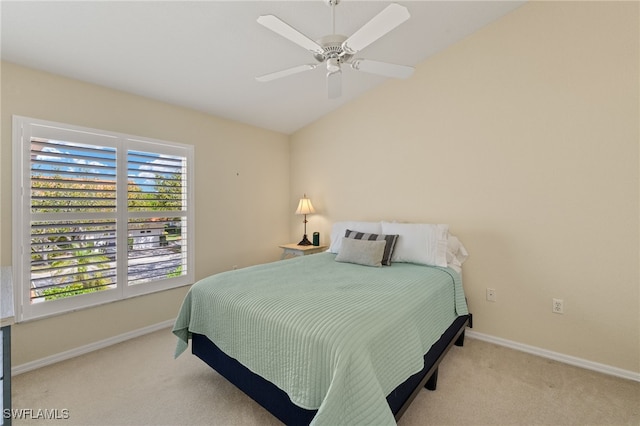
<box><xmin>173</xmin><ymin>253</ymin><xmax>468</xmax><ymax>425</ymax></box>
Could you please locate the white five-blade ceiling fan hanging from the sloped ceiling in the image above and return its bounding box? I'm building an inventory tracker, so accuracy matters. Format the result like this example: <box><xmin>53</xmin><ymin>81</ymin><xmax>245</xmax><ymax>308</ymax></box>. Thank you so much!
<box><xmin>256</xmin><ymin>0</ymin><xmax>413</xmax><ymax>98</ymax></box>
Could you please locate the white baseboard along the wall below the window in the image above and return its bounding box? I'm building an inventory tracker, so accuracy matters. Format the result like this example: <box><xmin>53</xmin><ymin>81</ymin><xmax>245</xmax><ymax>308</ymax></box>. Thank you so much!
<box><xmin>11</xmin><ymin>319</ymin><xmax>175</xmax><ymax>376</ymax></box>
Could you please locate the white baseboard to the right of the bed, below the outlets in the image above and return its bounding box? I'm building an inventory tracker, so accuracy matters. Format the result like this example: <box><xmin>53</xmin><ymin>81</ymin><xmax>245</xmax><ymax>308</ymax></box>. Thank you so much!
<box><xmin>465</xmin><ymin>329</ymin><xmax>640</xmax><ymax>382</ymax></box>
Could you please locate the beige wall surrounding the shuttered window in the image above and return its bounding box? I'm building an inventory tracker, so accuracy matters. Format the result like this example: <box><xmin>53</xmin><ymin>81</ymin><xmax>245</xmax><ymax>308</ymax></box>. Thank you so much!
<box><xmin>0</xmin><ymin>63</ymin><xmax>294</xmax><ymax>366</ymax></box>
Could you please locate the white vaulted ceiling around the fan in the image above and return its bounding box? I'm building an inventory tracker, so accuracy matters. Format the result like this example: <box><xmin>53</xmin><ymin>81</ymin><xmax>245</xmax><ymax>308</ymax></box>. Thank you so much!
<box><xmin>0</xmin><ymin>0</ymin><xmax>523</xmax><ymax>134</ymax></box>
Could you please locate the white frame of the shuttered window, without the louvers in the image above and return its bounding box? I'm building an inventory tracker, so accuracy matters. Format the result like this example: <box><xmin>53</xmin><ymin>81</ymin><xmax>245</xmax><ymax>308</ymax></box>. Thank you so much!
<box><xmin>12</xmin><ymin>115</ymin><xmax>196</xmax><ymax>322</ymax></box>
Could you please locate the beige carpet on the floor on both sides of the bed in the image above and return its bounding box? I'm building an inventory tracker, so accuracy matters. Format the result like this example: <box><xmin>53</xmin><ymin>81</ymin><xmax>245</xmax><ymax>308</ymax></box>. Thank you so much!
<box><xmin>13</xmin><ymin>330</ymin><xmax>640</xmax><ymax>426</ymax></box>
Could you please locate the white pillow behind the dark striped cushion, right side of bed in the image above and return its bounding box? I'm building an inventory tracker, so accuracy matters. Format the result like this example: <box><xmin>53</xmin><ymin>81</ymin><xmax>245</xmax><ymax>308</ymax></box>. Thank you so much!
<box><xmin>382</xmin><ymin>222</ymin><xmax>449</xmax><ymax>267</ymax></box>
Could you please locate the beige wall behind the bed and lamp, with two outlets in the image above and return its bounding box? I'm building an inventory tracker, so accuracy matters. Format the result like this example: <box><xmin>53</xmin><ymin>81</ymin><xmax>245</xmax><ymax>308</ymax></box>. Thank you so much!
<box><xmin>291</xmin><ymin>2</ymin><xmax>640</xmax><ymax>372</ymax></box>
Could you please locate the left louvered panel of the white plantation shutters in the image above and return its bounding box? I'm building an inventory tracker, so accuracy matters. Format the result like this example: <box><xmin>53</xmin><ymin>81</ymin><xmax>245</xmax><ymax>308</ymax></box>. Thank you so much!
<box><xmin>29</xmin><ymin>137</ymin><xmax>117</xmax><ymax>303</ymax></box>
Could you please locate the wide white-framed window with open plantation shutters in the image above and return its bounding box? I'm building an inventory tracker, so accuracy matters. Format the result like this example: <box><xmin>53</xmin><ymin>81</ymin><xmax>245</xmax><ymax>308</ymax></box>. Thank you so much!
<box><xmin>13</xmin><ymin>116</ymin><xmax>195</xmax><ymax>320</ymax></box>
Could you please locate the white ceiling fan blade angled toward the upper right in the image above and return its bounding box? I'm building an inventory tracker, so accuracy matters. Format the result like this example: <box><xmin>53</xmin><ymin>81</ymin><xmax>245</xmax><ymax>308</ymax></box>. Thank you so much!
<box><xmin>342</xmin><ymin>3</ymin><xmax>411</xmax><ymax>55</ymax></box>
